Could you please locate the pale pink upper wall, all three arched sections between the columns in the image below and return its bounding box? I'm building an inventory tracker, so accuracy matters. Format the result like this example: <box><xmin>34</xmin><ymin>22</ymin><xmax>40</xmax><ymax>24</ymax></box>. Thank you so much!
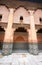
<box><xmin>0</xmin><ymin>5</ymin><xmax>42</xmax><ymax>24</ymax></box>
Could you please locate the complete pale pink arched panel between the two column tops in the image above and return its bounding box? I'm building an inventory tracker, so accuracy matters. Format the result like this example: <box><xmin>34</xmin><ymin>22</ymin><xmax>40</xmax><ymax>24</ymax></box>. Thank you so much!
<box><xmin>13</xmin><ymin>7</ymin><xmax>29</xmax><ymax>24</ymax></box>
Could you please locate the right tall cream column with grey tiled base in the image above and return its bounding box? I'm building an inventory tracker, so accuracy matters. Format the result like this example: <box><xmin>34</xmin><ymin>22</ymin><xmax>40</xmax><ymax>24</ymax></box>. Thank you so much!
<box><xmin>29</xmin><ymin>10</ymin><xmax>38</xmax><ymax>54</ymax></box>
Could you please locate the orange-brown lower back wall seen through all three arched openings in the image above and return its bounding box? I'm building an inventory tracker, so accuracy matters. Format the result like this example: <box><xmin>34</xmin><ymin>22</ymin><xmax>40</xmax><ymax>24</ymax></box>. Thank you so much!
<box><xmin>0</xmin><ymin>33</ymin><xmax>42</xmax><ymax>43</ymax></box>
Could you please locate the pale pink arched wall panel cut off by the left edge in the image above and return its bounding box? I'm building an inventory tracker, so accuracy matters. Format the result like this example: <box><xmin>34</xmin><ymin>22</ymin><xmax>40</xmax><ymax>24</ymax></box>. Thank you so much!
<box><xmin>0</xmin><ymin>5</ymin><xmax>9</xmax><ymax>23</ymax></box>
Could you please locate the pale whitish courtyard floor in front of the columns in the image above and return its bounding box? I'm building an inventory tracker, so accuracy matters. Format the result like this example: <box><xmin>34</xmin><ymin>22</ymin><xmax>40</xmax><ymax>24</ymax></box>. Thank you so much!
<box><xmin>0</xmin><ymin>52</ymin><xmax>42</xmax><ymax>65</ymax></box>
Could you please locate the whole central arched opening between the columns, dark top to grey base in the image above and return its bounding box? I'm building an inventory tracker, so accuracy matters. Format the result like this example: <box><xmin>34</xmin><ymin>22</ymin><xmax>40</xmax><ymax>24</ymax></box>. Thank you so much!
<box><xmin>13</xmin><ymin>27</ymin><xmax>28</xmax><ymax>50</ymax></box>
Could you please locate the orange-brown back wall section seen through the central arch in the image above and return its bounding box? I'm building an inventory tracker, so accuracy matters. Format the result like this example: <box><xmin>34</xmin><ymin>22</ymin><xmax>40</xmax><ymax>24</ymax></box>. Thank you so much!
<box><xmin>13</xmin><ymin>32</ymin><xmax>28</xmax><ymax>42</ymax></box>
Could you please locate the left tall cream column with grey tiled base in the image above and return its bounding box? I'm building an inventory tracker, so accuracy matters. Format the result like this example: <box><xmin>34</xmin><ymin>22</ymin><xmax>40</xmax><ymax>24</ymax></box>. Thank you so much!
<box><xmin>2</xmin><ymin>8</ymin><xmax>14</xmax><ymax>54</ymax></box>
